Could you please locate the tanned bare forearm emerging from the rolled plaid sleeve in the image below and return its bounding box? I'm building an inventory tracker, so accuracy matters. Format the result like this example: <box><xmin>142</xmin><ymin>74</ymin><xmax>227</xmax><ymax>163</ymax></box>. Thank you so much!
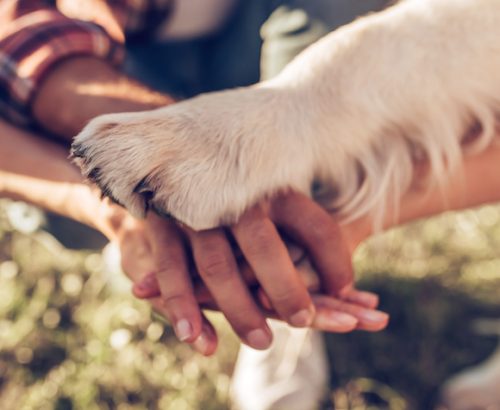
<box><xmin>33</xmin><ymin>57</ymin><xmax>173</xmax><ymax>140</ymax></box>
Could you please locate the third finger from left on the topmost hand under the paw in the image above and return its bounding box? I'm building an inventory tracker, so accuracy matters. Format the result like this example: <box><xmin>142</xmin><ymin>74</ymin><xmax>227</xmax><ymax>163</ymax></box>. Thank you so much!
<box><xmin>232</xmin><ymin>207</ymin><xmax>314</xmax><ymax>327</ymax></box>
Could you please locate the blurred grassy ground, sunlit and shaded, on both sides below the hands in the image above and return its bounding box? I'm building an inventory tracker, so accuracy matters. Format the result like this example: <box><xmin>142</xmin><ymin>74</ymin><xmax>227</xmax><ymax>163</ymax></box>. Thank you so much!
<box><xmin>0</xmin><ymin>201</ymin><xmax>500</xmax><ymax>410</ymax></box>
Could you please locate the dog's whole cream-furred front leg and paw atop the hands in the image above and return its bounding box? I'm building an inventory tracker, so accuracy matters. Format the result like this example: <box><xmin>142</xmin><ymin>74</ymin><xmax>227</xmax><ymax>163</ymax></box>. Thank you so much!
<box><xmin>74</xmin><ymin>0</ymin><xmax>500</xmax><ymax>229</ymax></box>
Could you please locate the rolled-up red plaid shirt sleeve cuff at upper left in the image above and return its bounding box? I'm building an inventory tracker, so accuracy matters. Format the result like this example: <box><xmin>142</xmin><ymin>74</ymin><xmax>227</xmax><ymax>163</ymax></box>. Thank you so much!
<box><xmin>0</xmin><ymin>9</ymin><xmax>123</xmax><ymax>125</ymax></box>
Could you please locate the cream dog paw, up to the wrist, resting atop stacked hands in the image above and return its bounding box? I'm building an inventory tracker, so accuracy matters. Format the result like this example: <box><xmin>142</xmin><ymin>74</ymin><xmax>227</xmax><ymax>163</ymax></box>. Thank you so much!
<box><xmin>72</xmin><ymin>88</ymin><xmax>312</xmax><ymax>229</ymax></box>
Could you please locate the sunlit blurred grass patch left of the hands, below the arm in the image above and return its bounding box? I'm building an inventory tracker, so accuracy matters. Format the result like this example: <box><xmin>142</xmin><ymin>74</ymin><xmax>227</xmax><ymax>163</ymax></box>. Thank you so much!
<box><xmin>0</xmin><ymin>202</ymin><xmax>237</xmax><ymax>410</ymax></box>
